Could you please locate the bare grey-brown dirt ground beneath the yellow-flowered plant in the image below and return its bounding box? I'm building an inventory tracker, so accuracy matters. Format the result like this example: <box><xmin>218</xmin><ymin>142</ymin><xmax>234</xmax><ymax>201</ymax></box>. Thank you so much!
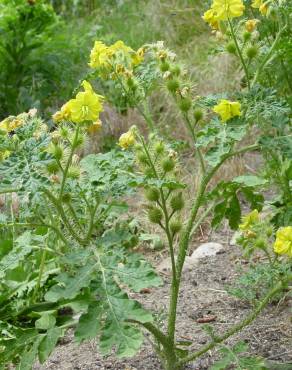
<box><xmin>34</xmin><ymin>223</ymin><xmax>292</xmax><ymax>370</ymax></box>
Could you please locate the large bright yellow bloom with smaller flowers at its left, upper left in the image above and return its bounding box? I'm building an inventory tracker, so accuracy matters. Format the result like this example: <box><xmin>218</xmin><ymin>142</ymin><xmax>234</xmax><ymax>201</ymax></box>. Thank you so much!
<box><xmin>53</xmin><ymin>81</ymin><xmax>104</xmax><ymax>123</ymax></box>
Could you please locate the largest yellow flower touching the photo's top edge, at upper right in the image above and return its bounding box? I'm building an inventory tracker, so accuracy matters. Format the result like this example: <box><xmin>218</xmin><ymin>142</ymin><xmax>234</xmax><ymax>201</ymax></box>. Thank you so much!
<box><xmin>211</xmin><ymin>0</ymin><xmax>245</xmax><ymax>21</ymax></box>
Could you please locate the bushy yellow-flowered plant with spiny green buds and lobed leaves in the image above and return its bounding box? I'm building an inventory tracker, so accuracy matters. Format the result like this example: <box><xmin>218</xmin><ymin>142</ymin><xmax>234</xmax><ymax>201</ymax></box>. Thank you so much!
<box><xmin>0</xmin><ymin>0</ymin><xmax>292</xmax><ymax>370</ymax></box>
